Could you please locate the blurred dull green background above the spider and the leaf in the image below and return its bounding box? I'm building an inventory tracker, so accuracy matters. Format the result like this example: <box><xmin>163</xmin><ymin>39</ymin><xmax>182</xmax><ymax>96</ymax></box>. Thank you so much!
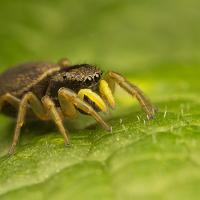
<box><xmin>0</xmin><ymin>0</ymin><xmax>200</xmax><ymax>71</ymax></box>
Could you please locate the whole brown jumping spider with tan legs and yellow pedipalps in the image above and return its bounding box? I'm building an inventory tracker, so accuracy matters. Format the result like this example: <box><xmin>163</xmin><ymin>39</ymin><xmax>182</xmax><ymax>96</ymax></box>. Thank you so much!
<box><xmin>0</xmin><ymin>59</ymin><xmax>155</xmax><ymax>154</ymax></box>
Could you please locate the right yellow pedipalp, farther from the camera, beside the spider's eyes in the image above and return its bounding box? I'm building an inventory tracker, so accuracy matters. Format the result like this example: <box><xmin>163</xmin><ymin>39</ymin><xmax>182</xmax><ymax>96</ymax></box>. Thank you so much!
<box><xmin>99</xmin><ymin>80</ymin><xmax>115</xmax><ymax>108</ymax></box>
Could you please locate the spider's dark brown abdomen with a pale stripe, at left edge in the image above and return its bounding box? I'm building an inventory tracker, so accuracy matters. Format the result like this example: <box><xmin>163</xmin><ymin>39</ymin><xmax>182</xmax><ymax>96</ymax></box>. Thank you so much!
<box><xmin>0</xmin><ymin>62</ymin><xmax>60</xmax><ymax>117</ymax></box>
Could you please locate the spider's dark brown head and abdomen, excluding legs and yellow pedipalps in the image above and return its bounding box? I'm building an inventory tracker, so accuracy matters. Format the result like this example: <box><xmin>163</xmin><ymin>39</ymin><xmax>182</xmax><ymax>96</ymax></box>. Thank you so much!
<box><xmin>0</xmin><ymin>62</ymin><xmax>101</xmax><ymax>118</ymax></box>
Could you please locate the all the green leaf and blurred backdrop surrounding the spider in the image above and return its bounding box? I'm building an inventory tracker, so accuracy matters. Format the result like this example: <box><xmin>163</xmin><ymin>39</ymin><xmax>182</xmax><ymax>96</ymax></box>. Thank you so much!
<box><xmin>0</xmin><ymin>0</ymin><xmax>200</xmax><ymax>200</ymax></box>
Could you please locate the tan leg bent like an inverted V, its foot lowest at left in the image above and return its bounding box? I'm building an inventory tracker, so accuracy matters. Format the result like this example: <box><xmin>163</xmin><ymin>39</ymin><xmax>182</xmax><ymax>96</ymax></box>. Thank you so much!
<box><xmin>7</xmin><ymin>92</ymin><xmax>48</xmax><ymax>154</ymax></box>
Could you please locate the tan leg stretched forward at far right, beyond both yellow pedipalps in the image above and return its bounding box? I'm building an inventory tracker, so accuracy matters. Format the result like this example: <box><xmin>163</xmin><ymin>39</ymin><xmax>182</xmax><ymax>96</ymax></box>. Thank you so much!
<box><xmin>107</xmin><ymin>71</ymin><xmax>155</xmax><ymax>119</ymax></box>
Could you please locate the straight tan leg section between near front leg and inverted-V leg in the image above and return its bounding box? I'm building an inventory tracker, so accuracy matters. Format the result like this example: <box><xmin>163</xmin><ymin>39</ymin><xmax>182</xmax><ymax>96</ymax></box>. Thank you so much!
<box><xmin>42</xmin><ymin>95</ymin><xmax>69</xmax><ymax>145</ymax></box>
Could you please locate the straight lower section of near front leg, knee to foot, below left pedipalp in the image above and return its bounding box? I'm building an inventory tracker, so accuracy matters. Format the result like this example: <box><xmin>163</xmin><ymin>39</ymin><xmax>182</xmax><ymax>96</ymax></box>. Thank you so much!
<box><xmin>58</xmin><ymin>88</ymin><xmax>112</xmax><ymax>131</ymax></box>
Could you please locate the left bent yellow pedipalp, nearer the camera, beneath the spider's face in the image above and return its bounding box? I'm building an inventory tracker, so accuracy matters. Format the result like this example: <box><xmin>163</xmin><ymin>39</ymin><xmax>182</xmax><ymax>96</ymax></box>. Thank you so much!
<box><xmin>78</xmin><ymin>89</ymin><xmax>108</xmax><ymax>112</ymax></box>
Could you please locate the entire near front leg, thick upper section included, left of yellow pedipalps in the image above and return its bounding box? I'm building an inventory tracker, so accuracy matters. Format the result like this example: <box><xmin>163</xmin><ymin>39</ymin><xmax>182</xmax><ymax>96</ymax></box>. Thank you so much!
<box><xmin>58</xmin><ymin>88</ymin><xmax>112</xmax><ymax>131</ymax></box>
